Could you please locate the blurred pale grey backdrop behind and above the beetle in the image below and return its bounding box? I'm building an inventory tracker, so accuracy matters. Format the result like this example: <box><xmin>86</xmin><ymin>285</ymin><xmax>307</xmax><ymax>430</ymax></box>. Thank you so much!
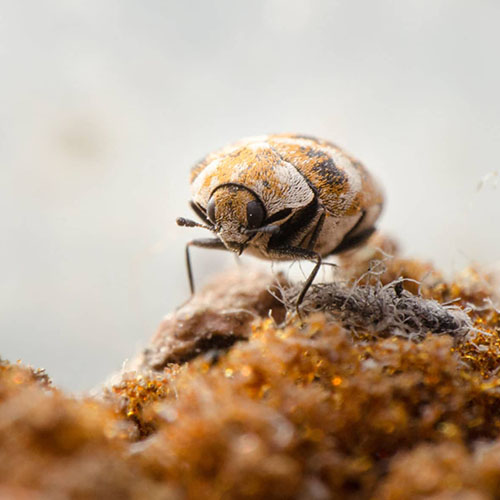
<box><xmin>0</xmin><ymin>0</ymin><xmax>500</xmax><ymax>390</ymax></box>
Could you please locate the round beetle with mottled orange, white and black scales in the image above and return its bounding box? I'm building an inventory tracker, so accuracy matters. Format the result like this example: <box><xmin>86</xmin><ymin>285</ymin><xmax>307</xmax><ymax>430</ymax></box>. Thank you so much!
<box><xmin>177</xmin><ymin>134</ymin><xmax>384</xmax><ymax>311</ymax></box>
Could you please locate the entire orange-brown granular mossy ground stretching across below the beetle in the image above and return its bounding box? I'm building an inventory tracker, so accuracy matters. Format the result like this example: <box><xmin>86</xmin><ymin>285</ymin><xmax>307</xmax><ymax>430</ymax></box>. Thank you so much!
<box><xmin>0</xmin><ymin>240</ymin><xmax>500</xmax><ymax>500</ymax></box>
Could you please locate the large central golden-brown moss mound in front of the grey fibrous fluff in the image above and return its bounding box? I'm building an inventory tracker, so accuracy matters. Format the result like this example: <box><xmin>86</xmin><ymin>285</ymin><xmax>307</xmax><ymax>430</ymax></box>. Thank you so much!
<box><xmin>126</xmin><ymin>316</ymin><xmax>500</xmax><ymax>498</ymax></box>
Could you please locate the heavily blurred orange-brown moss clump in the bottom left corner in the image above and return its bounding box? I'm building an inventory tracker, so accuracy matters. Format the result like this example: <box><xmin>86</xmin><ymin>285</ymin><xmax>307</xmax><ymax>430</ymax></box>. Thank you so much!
<box><xmin>0</xmin><ymin>362</ymin><xmax>172</xmax><ymax>499</ymax></box>
